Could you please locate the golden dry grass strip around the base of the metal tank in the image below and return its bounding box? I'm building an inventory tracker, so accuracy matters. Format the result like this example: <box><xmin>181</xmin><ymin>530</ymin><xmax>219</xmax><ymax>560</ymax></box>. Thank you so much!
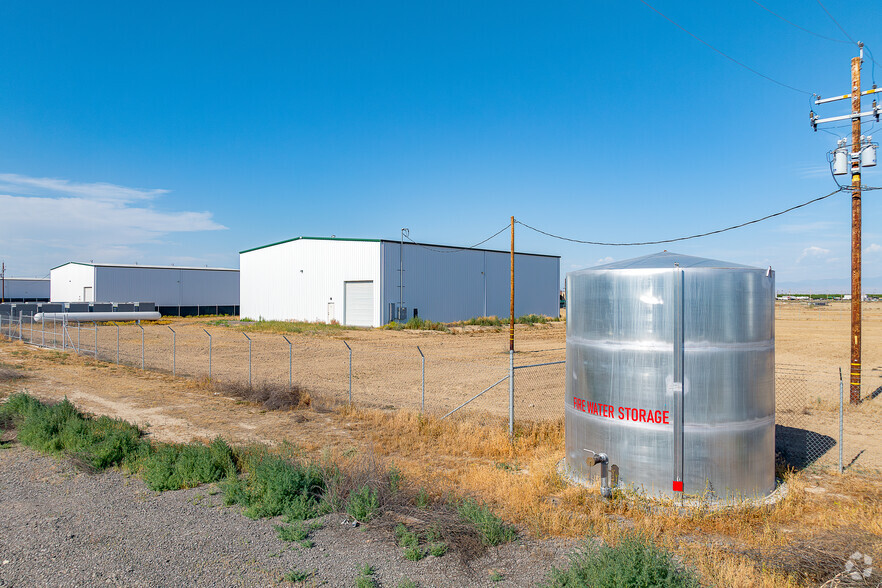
<box><xmin>342</xmin><ymin>407</ymin><xmax>882</xmax><ymax>586</ymax></box>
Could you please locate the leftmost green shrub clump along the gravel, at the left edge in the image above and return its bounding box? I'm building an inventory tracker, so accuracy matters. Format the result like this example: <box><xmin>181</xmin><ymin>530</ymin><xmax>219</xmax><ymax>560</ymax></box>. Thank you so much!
<box><xmin>0</xmin><ymin>393</ymin><xmax>144</xmax><ymax>470</ymax></box>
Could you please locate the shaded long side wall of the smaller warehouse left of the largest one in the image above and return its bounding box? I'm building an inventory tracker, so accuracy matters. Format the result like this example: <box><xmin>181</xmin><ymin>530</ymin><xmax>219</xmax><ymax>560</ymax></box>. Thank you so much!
<box><xmin>95</xmin><ymin>266</ymin><xmax>239</xmax><ymax>306</ymax></box>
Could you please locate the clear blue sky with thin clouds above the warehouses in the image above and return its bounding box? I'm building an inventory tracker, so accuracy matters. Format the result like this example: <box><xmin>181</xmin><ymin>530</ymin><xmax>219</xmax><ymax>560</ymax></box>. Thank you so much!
<box><xmin>0</xmin><ymin>0</ymin><xmax>882</xmax><ymax>289</ymax></box>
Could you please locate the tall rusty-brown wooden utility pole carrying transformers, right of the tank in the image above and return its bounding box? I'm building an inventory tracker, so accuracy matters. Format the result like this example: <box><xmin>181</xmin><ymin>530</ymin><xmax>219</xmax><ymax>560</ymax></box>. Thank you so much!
<box><xmin>849</xmin><ymin>51</ymin><xmax>863</xmax><ymax>404</ymax></box>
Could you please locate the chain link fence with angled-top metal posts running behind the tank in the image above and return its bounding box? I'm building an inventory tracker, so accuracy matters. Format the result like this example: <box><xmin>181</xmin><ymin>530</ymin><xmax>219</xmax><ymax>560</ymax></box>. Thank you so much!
<box><xmin>0</xmin><ymin>316</ymin><xmax>882</xmax><ymax>469</ymax></box>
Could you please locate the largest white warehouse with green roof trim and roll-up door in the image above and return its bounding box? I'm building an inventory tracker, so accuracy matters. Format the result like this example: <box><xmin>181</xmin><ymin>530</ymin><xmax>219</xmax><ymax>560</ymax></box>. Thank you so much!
<box><xmin>239</xmin><ymin>237</ymin><xmax>560</xmax><ymax>327</ymax></box>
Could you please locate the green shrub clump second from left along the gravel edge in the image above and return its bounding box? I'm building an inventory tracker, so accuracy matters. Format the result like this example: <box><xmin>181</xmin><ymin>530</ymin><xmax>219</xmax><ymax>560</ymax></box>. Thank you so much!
<box><xmin>141</xmin><ymin>437</ymin><xmax>236</xmax><ymax>491</ymax></box>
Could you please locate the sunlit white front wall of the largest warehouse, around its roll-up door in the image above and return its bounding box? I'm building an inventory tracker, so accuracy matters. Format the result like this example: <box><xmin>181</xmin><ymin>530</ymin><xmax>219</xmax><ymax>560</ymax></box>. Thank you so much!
<box><xmin>239</xmin><ymin>239</ymin><xmax>382</xmax><ymax>326</ymax></box>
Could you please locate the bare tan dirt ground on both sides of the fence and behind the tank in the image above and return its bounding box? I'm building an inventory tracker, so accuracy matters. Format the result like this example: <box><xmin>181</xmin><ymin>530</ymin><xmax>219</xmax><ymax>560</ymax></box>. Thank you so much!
<box><xmin>6</xmin><ymin>302</ymin><xmax>882</xmax><ymax>468</ymax></box>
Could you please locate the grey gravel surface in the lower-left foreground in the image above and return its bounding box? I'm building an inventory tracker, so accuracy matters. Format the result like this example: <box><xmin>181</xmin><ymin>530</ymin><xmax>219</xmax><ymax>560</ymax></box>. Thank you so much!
<box><xmin>0</xmin><ymin>444</ymin><xmax>573</xmax><ymax>588</ymax></box>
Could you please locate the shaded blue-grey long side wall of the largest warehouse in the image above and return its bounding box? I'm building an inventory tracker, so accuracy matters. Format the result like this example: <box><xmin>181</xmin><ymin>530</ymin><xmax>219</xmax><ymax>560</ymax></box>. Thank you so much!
<box><xmin>382</xmin><ymin>241</ymin><xmax>560</xmax><ymax>322</ymax></box>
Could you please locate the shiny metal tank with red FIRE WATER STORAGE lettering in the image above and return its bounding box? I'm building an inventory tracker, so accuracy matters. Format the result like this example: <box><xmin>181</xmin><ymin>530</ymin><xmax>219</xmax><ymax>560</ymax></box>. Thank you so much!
<box><xmin>565</xmin><ymin>251</ymin><xmax>775</xmax><ymax>499</ymax></box>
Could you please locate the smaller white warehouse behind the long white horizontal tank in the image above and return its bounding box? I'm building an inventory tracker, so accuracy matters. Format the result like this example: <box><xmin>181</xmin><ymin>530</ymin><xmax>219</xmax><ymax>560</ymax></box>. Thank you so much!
<box><xmin>49</xmin><ymin>262</ymin><xmax>239</xmax><ymax>316</ymax></box>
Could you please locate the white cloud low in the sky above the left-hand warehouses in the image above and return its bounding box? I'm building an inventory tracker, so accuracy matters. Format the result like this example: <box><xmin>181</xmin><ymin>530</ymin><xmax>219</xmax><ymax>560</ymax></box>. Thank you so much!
<box><xmin>0</xmin><ymin>169</ymin><xmax>226</xmax><ymax>275</ymax></box>
